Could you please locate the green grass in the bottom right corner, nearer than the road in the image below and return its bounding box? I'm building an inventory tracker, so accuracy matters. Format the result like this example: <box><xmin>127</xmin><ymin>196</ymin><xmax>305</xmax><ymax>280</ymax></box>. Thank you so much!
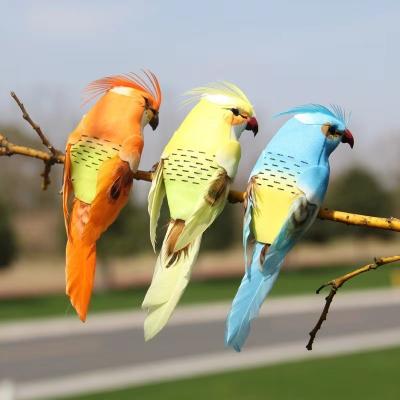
<box><xmin>61</xmin><ymin>348</ymin><xmax>400</xmax><ymax>400</ymax></box>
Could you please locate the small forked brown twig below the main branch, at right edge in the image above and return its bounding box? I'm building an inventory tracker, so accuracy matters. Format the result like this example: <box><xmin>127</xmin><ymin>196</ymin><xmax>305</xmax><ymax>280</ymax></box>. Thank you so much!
<box><xmin>306</xmin><ymin>256</ymin><xmax>400</xmax><ymax>350</ymax></box>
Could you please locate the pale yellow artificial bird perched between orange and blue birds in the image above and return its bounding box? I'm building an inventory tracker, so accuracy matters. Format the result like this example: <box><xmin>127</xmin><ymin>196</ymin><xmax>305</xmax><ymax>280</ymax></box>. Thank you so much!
<box><xmin>142</xmin><ymin>84</ymin><xmax>257</xmax><ymax>340</ymax></box>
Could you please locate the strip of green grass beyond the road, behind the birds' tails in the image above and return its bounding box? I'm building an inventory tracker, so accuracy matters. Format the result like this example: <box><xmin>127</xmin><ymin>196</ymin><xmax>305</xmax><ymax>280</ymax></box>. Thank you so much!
<box><xmin>0</xmin><ymin>267</ymin><xmax>394</xmax><ymax>320</ymax></box>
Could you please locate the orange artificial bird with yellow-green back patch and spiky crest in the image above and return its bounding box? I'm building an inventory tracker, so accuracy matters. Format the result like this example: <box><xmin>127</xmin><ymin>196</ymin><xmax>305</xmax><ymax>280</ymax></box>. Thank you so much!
<box><xmin>63</xmin><ymin>71</ymin><xmax>161</xmax><ymax>321</ymax></box>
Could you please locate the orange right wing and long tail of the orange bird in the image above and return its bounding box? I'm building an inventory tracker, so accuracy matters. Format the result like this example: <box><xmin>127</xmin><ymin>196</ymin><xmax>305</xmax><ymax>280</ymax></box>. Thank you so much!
<box><xmin>65</xmin><ymin>160</ymin><xmax>132</xmax><ymax>321</ymax></box>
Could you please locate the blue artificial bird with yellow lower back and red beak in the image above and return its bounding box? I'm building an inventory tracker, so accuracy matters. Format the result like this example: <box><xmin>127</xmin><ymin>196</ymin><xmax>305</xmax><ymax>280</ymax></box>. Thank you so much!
<box><xmin>225</xmin><ymin>104</ymin><xmax>354</xmax><ymax>351</ymax></box>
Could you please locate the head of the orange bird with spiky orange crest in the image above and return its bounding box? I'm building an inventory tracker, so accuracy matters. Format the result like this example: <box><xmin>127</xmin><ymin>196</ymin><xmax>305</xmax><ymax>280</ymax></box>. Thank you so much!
<box><xmin>86</xmin><ymin>70</ymin><xmax>162</xmax><ymax>131</ymax></box>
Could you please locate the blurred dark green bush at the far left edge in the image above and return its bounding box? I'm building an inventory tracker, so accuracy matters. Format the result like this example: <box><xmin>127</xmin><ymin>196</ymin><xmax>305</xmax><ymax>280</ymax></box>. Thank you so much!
<box><xmin>0</xmin><ymin>202</ymin><xmax>17</xmax><ymax>269</ymax></box>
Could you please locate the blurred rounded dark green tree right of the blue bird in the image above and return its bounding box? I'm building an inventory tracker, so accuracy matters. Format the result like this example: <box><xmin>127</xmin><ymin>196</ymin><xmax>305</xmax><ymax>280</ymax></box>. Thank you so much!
<box><xmin>306</xmin><ymin>166</ymin><xmax>395</xmax><ymax>242</ymax></box>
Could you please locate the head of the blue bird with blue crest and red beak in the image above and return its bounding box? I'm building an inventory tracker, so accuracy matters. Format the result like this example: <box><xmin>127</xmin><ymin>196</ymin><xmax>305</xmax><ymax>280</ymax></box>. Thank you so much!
<box><xmin>278</xmin><ymin>104</ymin><xmax>354</xmax><ymax>155</ymax></box>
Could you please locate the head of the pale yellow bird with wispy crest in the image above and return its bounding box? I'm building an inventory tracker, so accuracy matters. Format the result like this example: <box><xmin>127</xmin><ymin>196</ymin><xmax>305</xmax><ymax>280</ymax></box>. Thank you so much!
<box><xmin>188</xmin><ymin>82</ymin><xmax>258</xmax><ymax>139</ymax></box>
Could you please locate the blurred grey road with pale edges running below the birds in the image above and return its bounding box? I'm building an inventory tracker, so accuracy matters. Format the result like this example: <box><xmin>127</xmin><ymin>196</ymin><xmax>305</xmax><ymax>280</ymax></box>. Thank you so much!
<box><xmin>0</xmin><ymin>290</ymin><xmax>400</xmax><ymax>399</ymax></box>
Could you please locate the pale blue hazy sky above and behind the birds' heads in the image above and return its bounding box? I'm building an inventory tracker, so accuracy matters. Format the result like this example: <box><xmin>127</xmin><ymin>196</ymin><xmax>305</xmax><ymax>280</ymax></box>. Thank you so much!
<box><xmin>0</xmin><ymin>0</ymin><xmax>400</xmax><ymax>188</ymax></box>
